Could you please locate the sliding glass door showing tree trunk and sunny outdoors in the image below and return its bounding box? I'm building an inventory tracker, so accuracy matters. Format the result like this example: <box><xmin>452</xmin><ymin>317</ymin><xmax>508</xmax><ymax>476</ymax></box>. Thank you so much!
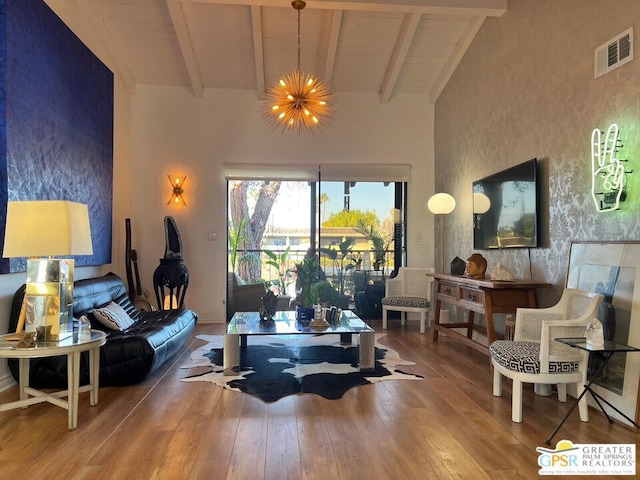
<box><xmin>227</xmin><ymin>167</ymin><xmax>406</xmax><ymax>316</ymax></box>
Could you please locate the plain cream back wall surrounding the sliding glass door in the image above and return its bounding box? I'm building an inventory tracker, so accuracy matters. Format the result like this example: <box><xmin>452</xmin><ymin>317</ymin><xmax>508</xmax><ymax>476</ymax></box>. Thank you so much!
<box><xmin>131</xmin><ymin>85</ymin><xmax>434</xmax><ymax>322</ymax></box>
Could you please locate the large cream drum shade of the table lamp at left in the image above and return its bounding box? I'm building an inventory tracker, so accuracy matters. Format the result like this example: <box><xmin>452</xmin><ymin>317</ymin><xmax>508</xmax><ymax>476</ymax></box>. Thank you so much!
<box><xmin>3</xmin><ymin>200</ymin><xmax>93</xmax><ymax>258</ymax></box>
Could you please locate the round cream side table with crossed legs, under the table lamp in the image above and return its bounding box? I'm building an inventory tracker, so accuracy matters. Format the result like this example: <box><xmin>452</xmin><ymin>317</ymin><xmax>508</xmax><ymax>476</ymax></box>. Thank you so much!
<box><xmin>0</xmin><ymin>330</ymin><xmax>107</xmax><ymax>430</ymax></box>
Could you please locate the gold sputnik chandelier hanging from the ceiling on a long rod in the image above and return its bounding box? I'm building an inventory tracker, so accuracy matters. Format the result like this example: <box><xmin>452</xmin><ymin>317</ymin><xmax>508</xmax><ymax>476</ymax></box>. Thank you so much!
<box><xmin>263</xmin><ymin>0</ymin><xmax>331</xmax><ymax>133</ymax></box>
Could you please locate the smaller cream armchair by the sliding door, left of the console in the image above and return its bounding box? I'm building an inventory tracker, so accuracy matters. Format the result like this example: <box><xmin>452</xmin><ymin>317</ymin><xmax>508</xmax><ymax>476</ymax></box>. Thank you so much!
<box><xmin>382</xmin><ymin>267</ymin><xmax>435</xmax><ymax>333</ymax></box>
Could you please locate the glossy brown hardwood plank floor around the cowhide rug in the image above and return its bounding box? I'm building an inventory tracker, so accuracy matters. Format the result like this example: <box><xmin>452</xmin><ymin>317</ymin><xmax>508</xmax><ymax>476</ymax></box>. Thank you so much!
<box><xmin>0</xmin><ymin>320</ymin><xmax>640</xmax><ymax>480</ymax></box>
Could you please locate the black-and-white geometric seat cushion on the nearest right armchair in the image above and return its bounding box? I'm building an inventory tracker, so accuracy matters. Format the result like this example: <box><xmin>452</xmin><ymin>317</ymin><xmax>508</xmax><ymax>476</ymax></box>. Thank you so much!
<box><xmin>489</xmin><ymin>340</ymin><xmax>578</xmax><ymax>374</ymax></box>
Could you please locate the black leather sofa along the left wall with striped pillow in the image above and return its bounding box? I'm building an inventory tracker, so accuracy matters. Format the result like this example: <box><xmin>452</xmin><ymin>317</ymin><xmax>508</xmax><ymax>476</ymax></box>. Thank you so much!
<box><xmin>8</xmin><ymin>273</ymin><xmax>198</xmax><ymax>388</ymax></box>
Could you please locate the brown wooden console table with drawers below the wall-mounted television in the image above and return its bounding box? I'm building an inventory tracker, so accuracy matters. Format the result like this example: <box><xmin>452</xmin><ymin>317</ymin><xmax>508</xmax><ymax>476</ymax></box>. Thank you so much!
<box><xmin>433</xmin><ymin>273</ymin><xmax>551</xmax><ymax>355</ymax></box>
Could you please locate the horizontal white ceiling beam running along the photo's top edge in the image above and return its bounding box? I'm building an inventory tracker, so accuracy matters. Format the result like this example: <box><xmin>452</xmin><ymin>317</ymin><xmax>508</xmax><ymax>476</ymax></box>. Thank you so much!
<box><xmin>179</xmin><ymin>0</ymin><xmax>509</xmax><ymax>17</ymax></box>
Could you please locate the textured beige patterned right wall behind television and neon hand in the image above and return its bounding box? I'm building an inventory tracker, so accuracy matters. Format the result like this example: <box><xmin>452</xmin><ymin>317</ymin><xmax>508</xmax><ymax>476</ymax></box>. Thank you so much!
<box><xmin>434</xmin><ymin>0</ymin><xmax>640</xmax><ymax>304</ymax></box>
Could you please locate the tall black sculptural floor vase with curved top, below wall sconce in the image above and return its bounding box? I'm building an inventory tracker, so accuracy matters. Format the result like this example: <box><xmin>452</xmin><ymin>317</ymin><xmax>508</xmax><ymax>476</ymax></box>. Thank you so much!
<box><xmin>153</xmin><ymin>216</ymin><xmax>189</xmax><ymax>310</ymax></box>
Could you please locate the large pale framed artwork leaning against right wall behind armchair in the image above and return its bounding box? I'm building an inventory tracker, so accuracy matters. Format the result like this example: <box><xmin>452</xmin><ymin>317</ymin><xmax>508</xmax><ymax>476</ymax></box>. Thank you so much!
<box><xmin>566</xmin><ymin>241</ymin><xmax>640</xmax><ymax>425</ymax></box>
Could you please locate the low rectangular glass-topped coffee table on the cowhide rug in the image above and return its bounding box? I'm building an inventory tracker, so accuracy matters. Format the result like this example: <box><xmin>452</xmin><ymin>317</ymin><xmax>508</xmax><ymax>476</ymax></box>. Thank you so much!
<box><xmin>223</xmin><ymin>310</ymin><xmax>375</xmax><ymax>375</ymax></box>
